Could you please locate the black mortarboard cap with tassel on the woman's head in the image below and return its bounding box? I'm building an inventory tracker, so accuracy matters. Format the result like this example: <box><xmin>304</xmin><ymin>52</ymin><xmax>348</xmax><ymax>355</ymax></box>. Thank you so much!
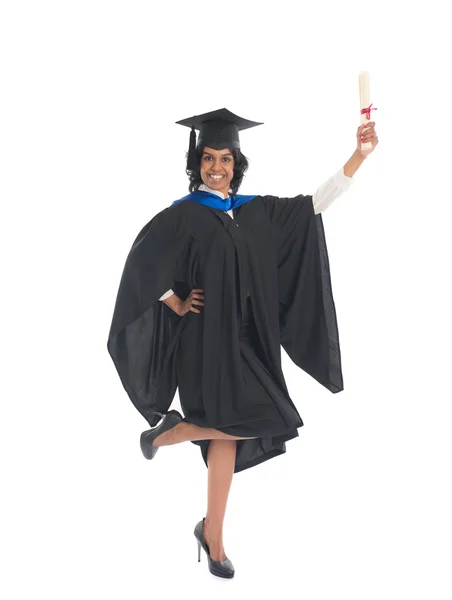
<box><xmin>176</xmin><ymin>108</ymin><xmax>263</xmax><ymax>170</ymax></box>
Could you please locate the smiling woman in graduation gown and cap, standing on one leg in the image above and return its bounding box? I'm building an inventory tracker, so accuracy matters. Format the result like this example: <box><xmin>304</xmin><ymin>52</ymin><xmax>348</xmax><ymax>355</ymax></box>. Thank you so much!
<box><xmin>107</xmin><ymin>108</ymin><xmax>378</xmax><ymax>577</ymax></box>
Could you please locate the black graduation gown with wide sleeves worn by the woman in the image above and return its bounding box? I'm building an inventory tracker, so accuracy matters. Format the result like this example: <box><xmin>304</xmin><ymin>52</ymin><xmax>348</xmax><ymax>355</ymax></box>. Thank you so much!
<box><xmin>107</xmin><ymin>195</ymin><xmax>343</xmax><ymax>473</ymax></box>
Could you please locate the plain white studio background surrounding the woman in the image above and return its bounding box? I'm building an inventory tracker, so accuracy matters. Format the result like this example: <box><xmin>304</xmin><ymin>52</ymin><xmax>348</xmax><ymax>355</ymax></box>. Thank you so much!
<box><xmin>0</xmin><ymin>0</ymin><xmax>452</xmax><ymax>600</ymax></box>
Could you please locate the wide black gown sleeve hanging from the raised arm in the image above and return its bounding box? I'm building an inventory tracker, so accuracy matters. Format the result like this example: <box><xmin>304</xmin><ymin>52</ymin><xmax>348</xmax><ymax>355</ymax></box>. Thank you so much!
<box><xmin>263</xmin><ymin>194</ymin><xmax>344</xmax><ymax>393</ymax></box>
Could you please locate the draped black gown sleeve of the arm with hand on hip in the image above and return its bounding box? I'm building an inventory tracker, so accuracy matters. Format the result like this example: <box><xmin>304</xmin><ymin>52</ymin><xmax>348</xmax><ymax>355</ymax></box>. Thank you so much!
<box><xmin>107</xmin><ymin>209</ymin><xmax>196</xmax><ymax>427</ymax></box>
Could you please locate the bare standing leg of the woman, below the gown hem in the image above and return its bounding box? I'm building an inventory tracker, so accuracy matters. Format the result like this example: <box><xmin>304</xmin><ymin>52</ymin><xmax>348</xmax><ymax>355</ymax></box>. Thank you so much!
<box><xmin>203</xmin><ymin>438</ymin><xmax>235</xmax><ymax>560</ymax></box>
